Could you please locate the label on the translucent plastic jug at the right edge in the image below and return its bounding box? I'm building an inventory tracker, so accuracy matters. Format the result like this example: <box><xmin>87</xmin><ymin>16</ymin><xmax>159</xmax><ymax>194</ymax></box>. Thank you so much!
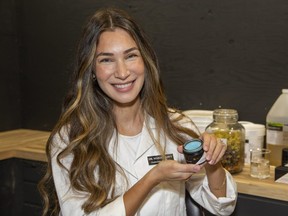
<box><xmin>266</xmin><ymin>122</ymin><xmax>288</xmax><ymax>145</ymax></box>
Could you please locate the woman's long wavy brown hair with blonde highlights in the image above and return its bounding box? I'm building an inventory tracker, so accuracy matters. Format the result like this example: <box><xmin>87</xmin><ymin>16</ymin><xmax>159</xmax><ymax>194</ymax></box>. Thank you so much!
<box><xmin>39</xmin><ymin>8</ymin><xmax>198</xmax><ymax>215</ymax></box>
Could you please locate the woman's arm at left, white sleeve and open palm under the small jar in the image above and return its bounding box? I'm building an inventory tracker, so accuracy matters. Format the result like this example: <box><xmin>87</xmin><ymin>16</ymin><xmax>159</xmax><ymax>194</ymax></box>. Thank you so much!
<box><xmin>52</xmin><ymin>145</ymin><xmax>201</xmax><ymax>216</ymax></box>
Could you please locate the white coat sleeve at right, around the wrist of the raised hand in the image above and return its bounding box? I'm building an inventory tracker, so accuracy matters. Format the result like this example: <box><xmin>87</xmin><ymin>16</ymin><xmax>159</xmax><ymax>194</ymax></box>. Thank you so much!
<box><xmin>186</xmin><ymin>170</ymin><xmax>237</xmax><ymax>215</ymax></box>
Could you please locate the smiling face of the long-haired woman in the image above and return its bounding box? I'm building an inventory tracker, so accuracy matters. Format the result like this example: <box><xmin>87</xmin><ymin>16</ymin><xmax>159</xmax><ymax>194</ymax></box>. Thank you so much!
<box><xmin>95</xmin><ymin>28</ymin><xmax>145</xmax><ymax>105</ymax></box>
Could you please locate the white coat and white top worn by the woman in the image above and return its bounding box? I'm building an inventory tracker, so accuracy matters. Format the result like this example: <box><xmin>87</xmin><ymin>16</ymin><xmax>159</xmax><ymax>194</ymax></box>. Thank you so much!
<box><xmin>52</xmin><ymin>115</ymin><xmax>237</xmax><ymax>216</ymax></box>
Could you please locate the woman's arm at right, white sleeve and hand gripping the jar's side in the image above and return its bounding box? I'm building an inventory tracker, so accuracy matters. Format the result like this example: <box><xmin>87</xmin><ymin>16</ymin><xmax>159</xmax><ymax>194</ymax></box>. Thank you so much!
<box><xmin>183</xmin><ymin>133</ymin><xmax>237</xmax><ymax>215</ymax></box>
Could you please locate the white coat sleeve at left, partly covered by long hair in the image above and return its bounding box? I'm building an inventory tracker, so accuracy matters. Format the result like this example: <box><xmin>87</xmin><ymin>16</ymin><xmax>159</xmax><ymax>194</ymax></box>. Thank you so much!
<box><xmin>51</xmin><ymin>132</ymin><xmax>126</xmax><ymax>216</ymax></box>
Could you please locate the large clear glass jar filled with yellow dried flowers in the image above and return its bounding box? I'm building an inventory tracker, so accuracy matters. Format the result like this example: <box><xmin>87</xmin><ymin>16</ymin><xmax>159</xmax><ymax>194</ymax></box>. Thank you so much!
<box><xmin>206</xmin><ymin>109</ymin><xmax>245</xmax><ymax>174</ymax></box>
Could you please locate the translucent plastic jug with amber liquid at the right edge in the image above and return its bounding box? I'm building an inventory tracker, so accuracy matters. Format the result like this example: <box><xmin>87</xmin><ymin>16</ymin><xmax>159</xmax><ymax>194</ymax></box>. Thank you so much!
<box><xmin>266</xmin><ymin>89</ymin><xmax>288</xmax><ymax>166</ymax></box>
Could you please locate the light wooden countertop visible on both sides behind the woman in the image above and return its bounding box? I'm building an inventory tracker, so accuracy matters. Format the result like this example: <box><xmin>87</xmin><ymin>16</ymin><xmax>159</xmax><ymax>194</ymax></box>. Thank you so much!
<box><xmin>0</xmin><ymin>129</ymin><xmax>288</xmax><ymax>201</ymax></box>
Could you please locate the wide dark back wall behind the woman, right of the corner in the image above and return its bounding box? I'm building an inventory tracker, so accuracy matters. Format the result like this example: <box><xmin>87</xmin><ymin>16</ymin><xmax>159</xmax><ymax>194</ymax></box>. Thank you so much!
<box><xmin>1</xmin><ymin>0</ymin><xmax>288</xmax><ymax>130</ymax></box>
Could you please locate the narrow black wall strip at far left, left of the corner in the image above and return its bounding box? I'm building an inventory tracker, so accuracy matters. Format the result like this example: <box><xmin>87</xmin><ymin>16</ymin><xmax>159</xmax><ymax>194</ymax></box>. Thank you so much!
<box><xmin>0</xmin><ymin>0</ymin><xmax>21</xmax><ymax>131</ymax></box>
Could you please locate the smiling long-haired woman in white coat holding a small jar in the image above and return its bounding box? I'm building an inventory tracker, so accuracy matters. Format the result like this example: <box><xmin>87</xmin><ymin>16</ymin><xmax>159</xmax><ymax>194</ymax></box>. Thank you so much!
<box><xmin>40</xmin><ymin>8</ymin><xmax>236</xmax><ymax>216</ymax></box>
